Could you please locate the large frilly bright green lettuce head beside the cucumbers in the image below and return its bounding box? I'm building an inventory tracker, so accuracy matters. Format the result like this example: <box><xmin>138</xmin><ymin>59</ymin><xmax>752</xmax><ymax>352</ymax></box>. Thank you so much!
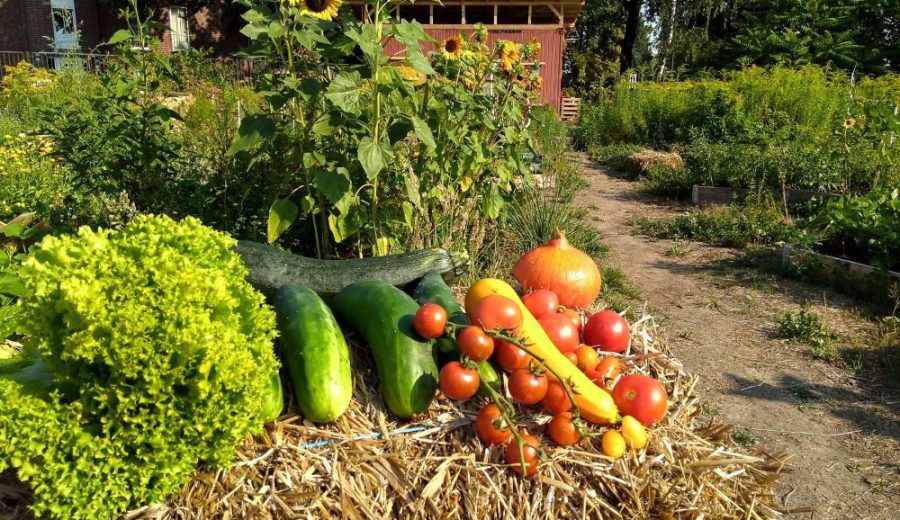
<box><xmin>0</xmin><ymin>216</ymin><xmax>277</xmax><ymax>519</ymax></box>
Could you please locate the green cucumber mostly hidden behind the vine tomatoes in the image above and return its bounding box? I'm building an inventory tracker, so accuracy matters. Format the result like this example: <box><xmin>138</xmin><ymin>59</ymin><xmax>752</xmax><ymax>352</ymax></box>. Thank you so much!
<box><xmin>413</xmin><ymin>271</ymin><xmax>502</xmax><ymax>397</ymax></box>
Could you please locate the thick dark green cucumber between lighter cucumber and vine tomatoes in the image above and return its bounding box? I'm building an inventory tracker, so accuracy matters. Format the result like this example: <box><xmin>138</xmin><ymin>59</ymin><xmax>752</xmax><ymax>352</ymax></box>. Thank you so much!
<box><xmin>332</xmin><ymin>280</ymin><xmax>438</xmax><ymax>419</ymax></box>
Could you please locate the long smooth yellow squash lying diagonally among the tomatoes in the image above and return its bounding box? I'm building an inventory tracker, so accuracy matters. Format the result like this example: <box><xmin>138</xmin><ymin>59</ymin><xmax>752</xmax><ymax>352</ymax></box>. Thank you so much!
<box><xmin>465</xmin><ymin>278</ymin><xmax>619</xmax><ymax>424</ymax></box>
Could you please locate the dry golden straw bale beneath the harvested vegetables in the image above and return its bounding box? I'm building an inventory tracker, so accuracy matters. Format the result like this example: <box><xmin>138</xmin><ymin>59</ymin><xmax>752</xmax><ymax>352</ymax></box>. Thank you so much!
<box><xmin>123</xmin><ymin>310</ymin><xmax>787</xmax><ymax>520</ymax></box>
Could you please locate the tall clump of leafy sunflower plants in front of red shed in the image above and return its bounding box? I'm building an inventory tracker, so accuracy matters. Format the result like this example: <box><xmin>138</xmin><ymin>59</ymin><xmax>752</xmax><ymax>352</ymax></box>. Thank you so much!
<box><xmin>236</xmin><ymin>0</ymin><xmax>539</xmax><ymax>256</ymax></box>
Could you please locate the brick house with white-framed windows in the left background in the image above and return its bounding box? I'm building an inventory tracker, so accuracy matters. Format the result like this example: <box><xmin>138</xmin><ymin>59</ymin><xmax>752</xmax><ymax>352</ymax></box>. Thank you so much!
<box><xmin>0</xmin><ymin>0</ymin><xmax>246</xmax><ymax>55</ymax></box>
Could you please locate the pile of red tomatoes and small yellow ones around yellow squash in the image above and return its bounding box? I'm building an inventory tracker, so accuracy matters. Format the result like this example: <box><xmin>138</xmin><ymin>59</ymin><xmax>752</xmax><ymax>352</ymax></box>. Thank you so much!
<box><xmin>413</xmin><ymin>290</ymin><xmax>666</xmax><ymax>475</ymax></box>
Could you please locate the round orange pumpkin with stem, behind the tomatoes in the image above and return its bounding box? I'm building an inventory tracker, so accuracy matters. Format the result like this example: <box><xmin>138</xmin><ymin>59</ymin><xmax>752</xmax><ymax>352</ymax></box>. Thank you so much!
<box><xmin>513</xmin><ymin>230</ymin><xmax>601</xmax><ymax>309</ymax></box>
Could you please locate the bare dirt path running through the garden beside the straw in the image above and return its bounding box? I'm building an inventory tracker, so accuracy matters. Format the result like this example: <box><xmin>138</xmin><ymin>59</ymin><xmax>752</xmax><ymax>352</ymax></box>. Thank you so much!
<box><xmin>577</xmin><ymin>156</ymin><xmax>900</xmax><ymax>519</ymax></box>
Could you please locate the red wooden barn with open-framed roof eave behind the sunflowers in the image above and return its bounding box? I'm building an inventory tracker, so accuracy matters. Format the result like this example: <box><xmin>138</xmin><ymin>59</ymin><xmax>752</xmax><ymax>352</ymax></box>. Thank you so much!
<box><xmin>351</xmin><ymin>0</ymin><xmax>584</xmax><ymax>110</ymax></box>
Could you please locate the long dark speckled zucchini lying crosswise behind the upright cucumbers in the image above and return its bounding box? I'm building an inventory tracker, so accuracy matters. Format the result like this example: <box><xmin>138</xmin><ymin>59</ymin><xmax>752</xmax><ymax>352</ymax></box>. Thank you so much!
<box><xmin>234</xmin><ymin>240</ymin><xmax>468</xmax><ymax>296</ymax></box>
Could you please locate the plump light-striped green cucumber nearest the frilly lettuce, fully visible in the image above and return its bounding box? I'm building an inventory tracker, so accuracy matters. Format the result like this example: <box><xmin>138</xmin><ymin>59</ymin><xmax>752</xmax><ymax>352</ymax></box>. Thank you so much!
<box><xmin>274</xmin><ymin>284</ymin><xmax>353</xmax><ymax>423</ymax></box>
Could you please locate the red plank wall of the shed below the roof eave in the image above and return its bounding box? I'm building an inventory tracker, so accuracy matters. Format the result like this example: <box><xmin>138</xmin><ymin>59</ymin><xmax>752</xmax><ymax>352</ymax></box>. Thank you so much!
<box><xmin>385</xmin><ymin>25</ymin><xmax>565</xmax><ymax>111</ymax></box>
